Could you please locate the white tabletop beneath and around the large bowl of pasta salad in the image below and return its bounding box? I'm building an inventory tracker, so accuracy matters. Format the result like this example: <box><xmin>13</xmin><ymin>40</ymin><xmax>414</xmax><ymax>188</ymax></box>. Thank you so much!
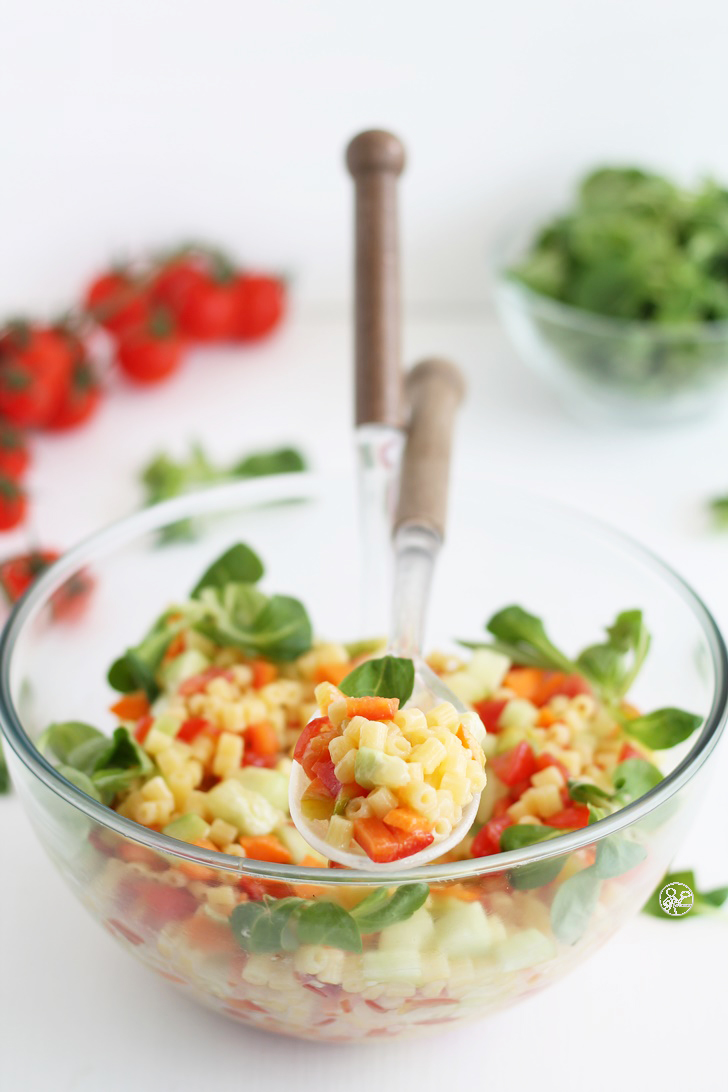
<box><xmin>0</xmin><ymin>313</ymin><xmax>728</xmax><ymax>1092</ymax></box>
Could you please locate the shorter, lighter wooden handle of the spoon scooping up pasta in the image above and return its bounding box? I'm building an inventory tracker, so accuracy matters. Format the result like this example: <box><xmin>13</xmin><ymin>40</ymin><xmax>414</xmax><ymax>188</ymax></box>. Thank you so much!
<box><xmin>394</xmin><ymin>357</ymin><xmax>465</xmax><ymax>538</ymax></box>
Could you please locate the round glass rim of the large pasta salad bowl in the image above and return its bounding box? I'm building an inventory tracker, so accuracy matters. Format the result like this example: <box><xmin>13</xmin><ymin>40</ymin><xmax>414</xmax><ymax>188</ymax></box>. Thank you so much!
<box><xmin>0</xmin><ymin>472</ymin><xmax>728</xmax><ymax>886</ymax></box>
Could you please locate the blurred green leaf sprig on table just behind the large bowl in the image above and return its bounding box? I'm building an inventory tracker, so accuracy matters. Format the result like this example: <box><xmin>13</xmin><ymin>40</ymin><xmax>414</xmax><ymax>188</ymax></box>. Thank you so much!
<box><xmin>141</xmin><ymin>434</ymin><xmax>307</xmax><ymax>542</ymax></box>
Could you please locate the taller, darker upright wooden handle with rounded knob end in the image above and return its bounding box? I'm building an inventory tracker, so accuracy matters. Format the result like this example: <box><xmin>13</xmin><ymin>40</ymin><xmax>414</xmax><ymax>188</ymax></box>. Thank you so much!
<box><xmin>346</xmin><ymin>129</ymin><xmax>405</xmax><ymax>427</ymax></box>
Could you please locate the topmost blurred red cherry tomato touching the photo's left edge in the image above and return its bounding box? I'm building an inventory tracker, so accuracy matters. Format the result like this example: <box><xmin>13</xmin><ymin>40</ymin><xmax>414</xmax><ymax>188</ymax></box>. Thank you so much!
<box><xmin>0</xmin><ymin>323</ymin><xmax>73</xmax><ymax>427</ymax></box>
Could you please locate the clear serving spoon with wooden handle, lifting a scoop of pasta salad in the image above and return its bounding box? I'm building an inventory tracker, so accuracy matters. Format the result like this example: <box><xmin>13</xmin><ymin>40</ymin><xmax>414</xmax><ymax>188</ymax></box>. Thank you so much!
<box><xmin>288</xmin><ymin>358</ymin><xmax>485</xmax><ymax>871</ymax></box>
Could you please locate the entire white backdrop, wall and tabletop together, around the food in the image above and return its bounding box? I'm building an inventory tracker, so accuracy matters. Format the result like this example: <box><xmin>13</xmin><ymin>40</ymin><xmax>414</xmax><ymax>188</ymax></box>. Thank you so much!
<box><xmin>0</xmin><ymin>0</ymin><xmax>728</xmax><ymax>1092</ymax></box>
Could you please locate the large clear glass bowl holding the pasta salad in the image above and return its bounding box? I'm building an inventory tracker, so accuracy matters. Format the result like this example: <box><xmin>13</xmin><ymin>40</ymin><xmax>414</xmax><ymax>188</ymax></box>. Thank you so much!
<box><xmin>0</xmin><ymin>474</ymin><xmax>727</xmax><ymax>1042</ymax></box>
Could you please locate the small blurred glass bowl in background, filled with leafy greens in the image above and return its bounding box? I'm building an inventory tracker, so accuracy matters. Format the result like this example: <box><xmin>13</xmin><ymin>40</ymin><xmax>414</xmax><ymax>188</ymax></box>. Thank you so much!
<box><xmin>494</xmin><ymin>218</ymin><xmax>728</xmax><ymax>424</ymax></box>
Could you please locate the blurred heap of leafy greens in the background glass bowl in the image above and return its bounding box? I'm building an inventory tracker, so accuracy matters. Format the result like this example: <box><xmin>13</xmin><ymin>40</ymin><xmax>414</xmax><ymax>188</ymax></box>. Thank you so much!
<box><xmin>509</xmin><ymin>167</ymin><xmax>728</xmax><ymax>395</ymax></box>
